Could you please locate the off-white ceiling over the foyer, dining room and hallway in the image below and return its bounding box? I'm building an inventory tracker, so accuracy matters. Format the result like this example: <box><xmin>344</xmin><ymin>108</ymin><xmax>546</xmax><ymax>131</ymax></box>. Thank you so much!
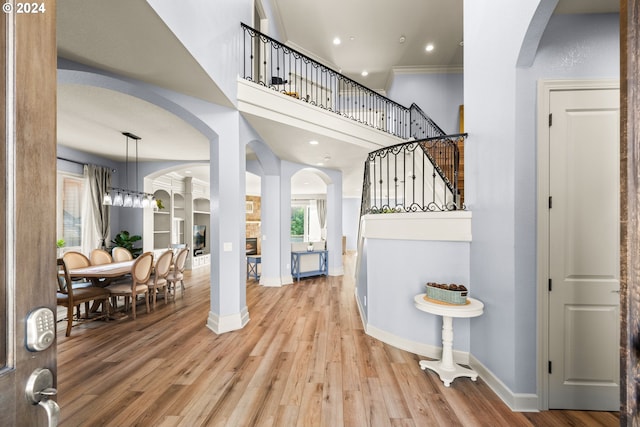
<box><xmin>57</xmin><ymin>0</ymin><xmax>619</xmax><ymax>197</ymax></box>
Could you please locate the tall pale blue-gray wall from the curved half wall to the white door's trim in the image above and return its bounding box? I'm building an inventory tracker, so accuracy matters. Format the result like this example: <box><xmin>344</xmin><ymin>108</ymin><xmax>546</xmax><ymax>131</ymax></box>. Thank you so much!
<box><xmin>464</xmin><ymin>0</ymin><xmax>619</xmax><ymax>393</ymax></box>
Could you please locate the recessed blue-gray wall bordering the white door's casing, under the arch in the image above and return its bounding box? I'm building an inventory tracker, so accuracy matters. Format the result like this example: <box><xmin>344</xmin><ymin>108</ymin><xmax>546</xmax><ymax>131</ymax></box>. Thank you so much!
<box><xmin>514</xmin><ymin>14</ymin><xmax>620</xmax><ymax>390</ymax></box>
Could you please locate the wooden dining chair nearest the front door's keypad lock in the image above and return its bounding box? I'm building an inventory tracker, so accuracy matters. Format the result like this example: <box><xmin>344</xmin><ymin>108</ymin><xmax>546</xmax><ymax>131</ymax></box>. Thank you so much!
<box><xmin>56</xmin><ymin>258</ymin><xmax>111</xmax><ymax>336</ymax></box>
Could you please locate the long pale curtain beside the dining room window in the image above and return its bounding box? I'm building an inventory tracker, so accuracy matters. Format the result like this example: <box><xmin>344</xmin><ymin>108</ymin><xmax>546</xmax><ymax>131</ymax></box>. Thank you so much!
<box><xmin>82</xmin><ymin>165</ymin><xmax>111</xmax><ymax>254</ymax></box>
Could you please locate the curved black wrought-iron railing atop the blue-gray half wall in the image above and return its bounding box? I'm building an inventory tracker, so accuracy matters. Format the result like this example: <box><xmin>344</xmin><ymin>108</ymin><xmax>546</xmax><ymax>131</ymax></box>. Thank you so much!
<box><xmin>360</xmin><ymin>134</ymin><xmax>467</xmax><ymax>215</ymax></box>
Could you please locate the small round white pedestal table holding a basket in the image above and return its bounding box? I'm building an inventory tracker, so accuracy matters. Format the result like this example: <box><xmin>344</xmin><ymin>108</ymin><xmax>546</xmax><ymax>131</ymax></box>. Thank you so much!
<box><xmin>414</xmin><ymin>294</ymin><xmax>484</xmax><ymax>387</ymax></box>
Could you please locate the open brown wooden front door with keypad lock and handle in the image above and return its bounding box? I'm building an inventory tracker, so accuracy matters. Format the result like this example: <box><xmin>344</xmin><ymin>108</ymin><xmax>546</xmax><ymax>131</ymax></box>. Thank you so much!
<box><xmin>0</xmin><ymin>0</ymin><xmax>56</xmax><ymax>426</ymax></box>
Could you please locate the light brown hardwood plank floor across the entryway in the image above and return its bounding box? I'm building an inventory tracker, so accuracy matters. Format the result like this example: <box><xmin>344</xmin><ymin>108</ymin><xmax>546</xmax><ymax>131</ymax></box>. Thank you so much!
<box><xmin>57</xmin><ymin>256</ymin><xmax>618</xmax><ymax>427</ymax></box>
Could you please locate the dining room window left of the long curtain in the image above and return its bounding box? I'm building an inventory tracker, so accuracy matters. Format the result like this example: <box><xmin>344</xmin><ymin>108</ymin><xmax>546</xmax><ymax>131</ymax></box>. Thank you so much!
<box><xmin>56</xmin><ymin>173</ymin><xmax>84</xmax><ymax>250</ymax></box>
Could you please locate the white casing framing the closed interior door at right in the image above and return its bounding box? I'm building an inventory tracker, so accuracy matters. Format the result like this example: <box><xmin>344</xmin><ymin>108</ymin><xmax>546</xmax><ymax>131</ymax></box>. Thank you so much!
<box><xmin>536</xmin><ymin>79</ymin><xmax>620</xmax><ymax>410</ymax></box>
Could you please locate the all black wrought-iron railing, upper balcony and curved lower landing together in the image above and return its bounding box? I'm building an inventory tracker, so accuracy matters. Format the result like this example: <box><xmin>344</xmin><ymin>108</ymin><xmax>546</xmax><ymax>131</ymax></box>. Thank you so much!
<box><xmin>241</xmin><ymin>24</ymin><xmax>466</xmax><ymax>214</ymax></box>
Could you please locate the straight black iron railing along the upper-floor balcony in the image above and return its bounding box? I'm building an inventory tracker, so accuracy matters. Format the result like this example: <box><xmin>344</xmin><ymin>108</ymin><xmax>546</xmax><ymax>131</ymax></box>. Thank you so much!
<box><xmin>242</xmin><ymin>24</ymin><xmax>445</xmax><ymax>139</ymax></box>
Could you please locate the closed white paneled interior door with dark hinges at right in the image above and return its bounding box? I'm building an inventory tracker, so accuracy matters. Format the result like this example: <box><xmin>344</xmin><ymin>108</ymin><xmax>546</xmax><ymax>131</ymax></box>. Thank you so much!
<box><xmin>548</xmin><ymin>89</ymin><xmax>620</xmax><ymax>411</ymax></box>
